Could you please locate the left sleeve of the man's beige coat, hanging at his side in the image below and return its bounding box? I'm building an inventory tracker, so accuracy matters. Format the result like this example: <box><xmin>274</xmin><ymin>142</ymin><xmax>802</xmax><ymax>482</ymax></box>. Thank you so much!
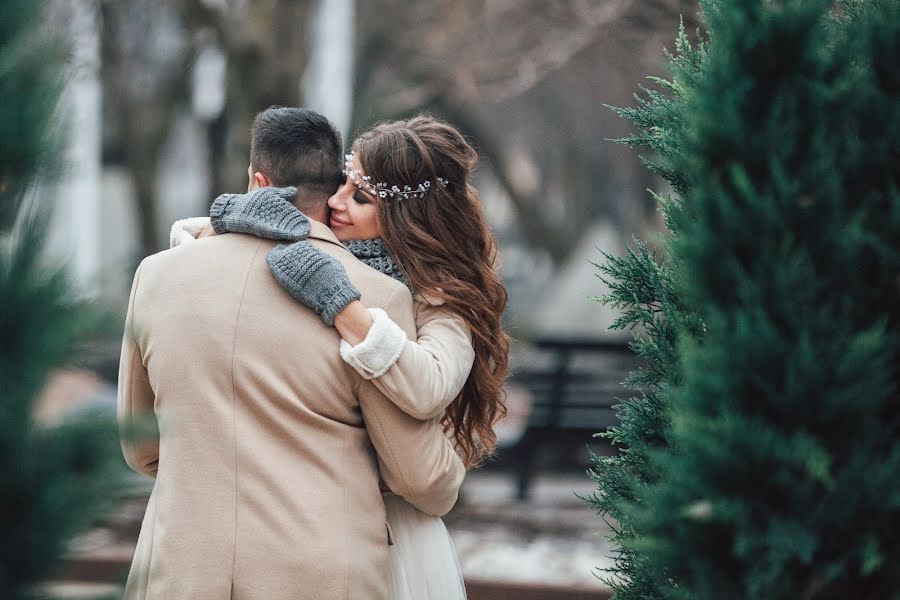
<box><xmin>116</xmin><ymin>263</ymin><xmax>159</xmax><ymax>478</ymax></box>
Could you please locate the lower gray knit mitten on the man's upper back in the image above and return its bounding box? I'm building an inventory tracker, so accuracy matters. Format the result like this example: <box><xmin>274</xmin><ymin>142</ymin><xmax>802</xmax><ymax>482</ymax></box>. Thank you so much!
<box><xmin>266</xmin><ymin>241</ymin><xmax>360</xmax><ymax>325</ymax></box>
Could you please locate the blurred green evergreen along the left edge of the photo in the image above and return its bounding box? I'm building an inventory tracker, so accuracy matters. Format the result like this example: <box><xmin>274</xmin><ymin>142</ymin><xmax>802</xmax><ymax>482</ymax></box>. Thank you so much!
<box><xmin>0</xmin><ymin>0</ymin><xmax>123</xmax><ymax>599</ymax></box>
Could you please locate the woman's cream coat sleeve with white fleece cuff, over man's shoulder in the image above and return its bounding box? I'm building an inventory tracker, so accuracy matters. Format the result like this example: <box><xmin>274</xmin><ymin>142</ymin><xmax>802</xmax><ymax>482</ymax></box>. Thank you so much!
<box><xmin>341</xmin><ymin>300</ymin><xmax>475</xmax><ymax>419</ymax></box>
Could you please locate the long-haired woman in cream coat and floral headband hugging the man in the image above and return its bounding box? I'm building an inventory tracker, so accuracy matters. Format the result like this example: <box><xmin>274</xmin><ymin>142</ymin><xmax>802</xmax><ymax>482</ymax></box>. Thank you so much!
<box><xmin>172</xmin><ymin>116</ymin><xmax>509</xmax><ymax>600</ymax></box>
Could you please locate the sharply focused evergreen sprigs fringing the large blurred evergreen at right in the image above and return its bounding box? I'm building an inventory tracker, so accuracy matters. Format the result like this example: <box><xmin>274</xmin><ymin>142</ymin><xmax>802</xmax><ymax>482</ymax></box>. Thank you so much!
<box><xmin>588</xmin><ymin>19</ymin><xmax>707</xmax><ymax>600</ymax></box>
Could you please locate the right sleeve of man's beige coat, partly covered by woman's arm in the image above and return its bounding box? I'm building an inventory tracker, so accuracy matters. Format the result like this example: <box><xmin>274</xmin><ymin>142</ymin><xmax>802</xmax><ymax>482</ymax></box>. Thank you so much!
<box><xmin>358</xmin><ymin>288</ymin><xmax>466</xmax><ymax>516</ymax></box>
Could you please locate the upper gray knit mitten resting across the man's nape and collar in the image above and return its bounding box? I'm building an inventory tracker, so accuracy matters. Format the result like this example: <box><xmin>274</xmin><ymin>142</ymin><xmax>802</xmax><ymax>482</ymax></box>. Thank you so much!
<box><xmin>209</xmin><ymin>187</ymin><xmax>309</xmax><ymax>242</ymax></box>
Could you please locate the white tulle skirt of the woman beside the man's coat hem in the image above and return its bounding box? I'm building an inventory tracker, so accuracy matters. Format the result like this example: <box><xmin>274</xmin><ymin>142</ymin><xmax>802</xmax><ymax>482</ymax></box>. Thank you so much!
<box><xmin>384</xmin><ymin>494</ymin><xmax>466</xmax><ymax>600</ymax></box>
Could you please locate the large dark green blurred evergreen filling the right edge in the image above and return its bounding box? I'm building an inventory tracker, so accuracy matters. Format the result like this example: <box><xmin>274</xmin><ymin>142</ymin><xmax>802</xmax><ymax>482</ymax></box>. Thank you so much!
<box><xmin>620</xmin><ymin>0</ymin><xmax>900</xmax><ymax>600</ymax></box>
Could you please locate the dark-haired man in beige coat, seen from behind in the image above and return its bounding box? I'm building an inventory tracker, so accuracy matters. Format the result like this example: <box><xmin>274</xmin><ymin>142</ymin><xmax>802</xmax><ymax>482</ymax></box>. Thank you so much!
<box><xmin>119</xmin><ymin>109</ymin><xmax>465</xmax><ymax>600</ymax></box>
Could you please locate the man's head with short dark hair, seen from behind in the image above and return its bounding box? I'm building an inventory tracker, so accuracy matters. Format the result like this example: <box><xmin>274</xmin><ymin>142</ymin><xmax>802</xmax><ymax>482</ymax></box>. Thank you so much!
<box><xmin>250</xmin><ymin>106</ymin><xmax>343</xmax><ymax>209</ymax></box>
